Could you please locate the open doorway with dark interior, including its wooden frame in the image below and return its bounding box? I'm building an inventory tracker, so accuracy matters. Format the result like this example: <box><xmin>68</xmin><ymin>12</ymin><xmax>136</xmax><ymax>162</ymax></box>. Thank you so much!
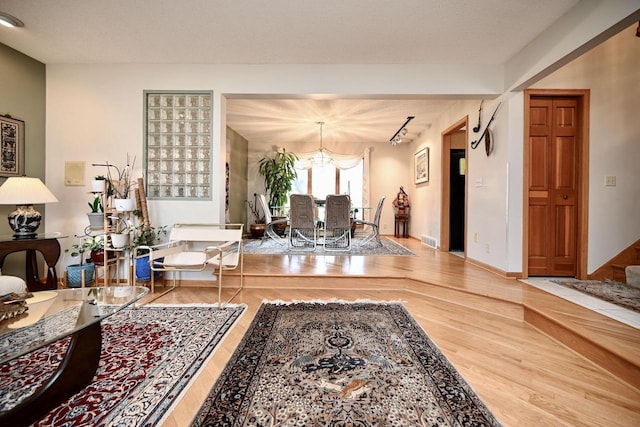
<box><xmin>440</xmin><ymin>117</ymin><xmax>469</xmax><ymax>256</ymax></box>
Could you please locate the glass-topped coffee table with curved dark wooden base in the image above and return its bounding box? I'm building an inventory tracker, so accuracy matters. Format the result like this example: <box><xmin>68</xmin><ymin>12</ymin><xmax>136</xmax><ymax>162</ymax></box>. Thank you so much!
<box><xmin>0</xmin><ymin>286</ymin><xmax>149</xmax><ymax>426</ymax></box>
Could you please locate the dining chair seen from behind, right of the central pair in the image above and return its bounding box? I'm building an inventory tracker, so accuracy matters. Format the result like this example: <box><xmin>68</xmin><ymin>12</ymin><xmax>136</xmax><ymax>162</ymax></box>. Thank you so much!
<box><xmin>324</xmin><ymin>194</ymin><xmax>351</xmax><ymax>251</ymax></box>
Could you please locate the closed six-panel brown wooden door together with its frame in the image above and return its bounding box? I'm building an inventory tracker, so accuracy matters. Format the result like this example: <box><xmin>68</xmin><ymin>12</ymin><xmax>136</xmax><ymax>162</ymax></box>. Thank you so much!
<box><xmin>523</xmin><ymin>90</ymin><xmax>589</xmax><ymax>278</ymax></box>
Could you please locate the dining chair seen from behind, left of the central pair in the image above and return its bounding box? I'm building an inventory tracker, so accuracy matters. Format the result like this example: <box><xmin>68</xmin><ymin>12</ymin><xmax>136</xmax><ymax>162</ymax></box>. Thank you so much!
<box><xmin>289</xmin><ymin>194</ymin><xmax>317</xmax><ymax>251</ymax></box>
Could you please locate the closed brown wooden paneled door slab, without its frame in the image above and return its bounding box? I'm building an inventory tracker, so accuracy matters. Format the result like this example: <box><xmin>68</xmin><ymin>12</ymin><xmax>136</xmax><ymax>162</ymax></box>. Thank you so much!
<box><xmin>527</xmin><ymin>97</ymin><xmax>580</xmax><ymax>276</ymax></box>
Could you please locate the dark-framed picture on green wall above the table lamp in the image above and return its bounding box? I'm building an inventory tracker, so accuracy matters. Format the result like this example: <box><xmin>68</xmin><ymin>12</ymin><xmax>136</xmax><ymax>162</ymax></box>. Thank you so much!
<box><xmin>0</xmin><ymin>116</ymin><xmax>24</xmax><ymax>176</ymax></box>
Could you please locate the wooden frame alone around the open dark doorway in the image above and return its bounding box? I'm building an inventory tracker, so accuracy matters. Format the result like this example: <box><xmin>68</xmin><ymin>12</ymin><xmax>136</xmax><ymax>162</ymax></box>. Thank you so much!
<box><xmin>440</xmin><ymin>115</ymin><xmax>469</xmax><ymax>254</ymax></box>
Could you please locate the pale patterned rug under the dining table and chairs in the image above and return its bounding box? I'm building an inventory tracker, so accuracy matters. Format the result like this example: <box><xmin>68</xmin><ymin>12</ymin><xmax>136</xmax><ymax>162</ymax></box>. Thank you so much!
<box><xmin>244</xmin><ymin>237</ymin><xmax>416</xmax><ymax>256</ymax></box>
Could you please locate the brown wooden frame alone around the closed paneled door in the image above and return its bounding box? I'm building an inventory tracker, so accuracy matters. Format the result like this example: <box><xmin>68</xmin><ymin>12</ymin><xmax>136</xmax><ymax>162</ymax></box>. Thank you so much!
<box><xmin>522</xmin><ymin>89</ymin><xmax>590</xmax><ymax>279</ymax></box>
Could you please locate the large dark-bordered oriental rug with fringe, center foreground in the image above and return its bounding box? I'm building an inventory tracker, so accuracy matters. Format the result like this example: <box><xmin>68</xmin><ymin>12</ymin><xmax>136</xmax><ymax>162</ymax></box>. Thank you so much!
<box><xmin>192</xmin><ymin>301</ymin><xmax>500</xmax><ymax>427</ymax></box>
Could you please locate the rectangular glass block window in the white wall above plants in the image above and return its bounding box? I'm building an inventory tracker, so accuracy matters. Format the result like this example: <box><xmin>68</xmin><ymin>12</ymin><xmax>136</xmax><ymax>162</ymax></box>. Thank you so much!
<box><xmin>144</xmin><ymin>91</ymin><xmax>213</xmax><ymax>200</ymax></box>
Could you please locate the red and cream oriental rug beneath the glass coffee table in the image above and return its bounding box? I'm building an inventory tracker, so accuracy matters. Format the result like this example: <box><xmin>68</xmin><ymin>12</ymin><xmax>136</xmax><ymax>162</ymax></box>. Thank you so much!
<box><xmin>0</xmin><ymin>304</ymin><xmax>246</xmax><ymax>426</ymax></box>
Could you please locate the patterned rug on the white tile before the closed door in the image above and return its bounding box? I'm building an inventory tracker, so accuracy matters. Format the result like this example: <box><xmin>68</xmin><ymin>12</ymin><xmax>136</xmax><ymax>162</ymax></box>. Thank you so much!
<box><xmin>551</xmin><ymin>279</ymin><xmax>640</xmax><ymax>313</ymax></box>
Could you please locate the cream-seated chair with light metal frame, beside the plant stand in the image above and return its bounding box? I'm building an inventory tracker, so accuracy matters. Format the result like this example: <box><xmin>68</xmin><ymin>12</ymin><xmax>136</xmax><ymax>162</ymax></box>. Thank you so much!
<box><xmin>134</xmin><ymin>224</ymin><xmax>244</xmax><ymax>306</ymax></box>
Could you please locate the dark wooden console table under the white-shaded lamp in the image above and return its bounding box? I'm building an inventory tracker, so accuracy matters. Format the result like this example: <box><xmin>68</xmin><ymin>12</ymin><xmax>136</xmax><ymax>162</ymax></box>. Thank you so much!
<box><xmin>0</xmin><ymin>233</ymin><xmax>66</xmax><ymax>292</ymax></box>
